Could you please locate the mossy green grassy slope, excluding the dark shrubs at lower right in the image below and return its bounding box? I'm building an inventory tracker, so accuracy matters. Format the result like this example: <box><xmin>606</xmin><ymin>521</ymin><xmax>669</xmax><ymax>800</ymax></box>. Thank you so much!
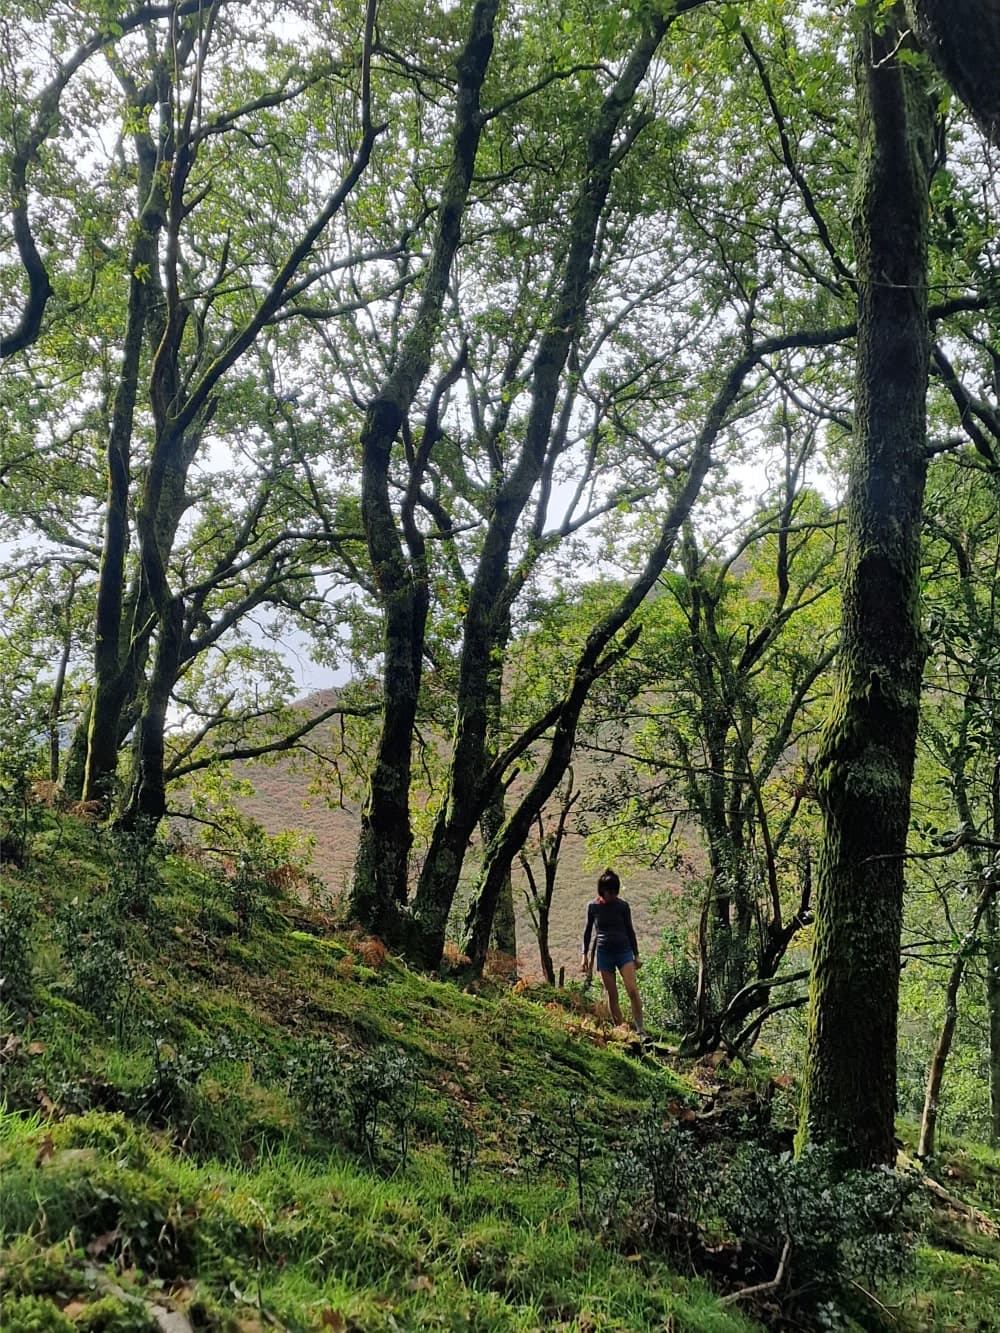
<box><xmin>0</xmin><ymin>824</ymin><xmax>1000</xmax><ymax>1333</ymax></box>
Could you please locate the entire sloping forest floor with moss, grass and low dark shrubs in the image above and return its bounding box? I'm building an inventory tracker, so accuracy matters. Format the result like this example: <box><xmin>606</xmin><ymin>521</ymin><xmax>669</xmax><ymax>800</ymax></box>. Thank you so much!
<box><xmin>0</xmin><ymin>818</ymin><xmax>1000</xmax><ymax>1333</ymax></box>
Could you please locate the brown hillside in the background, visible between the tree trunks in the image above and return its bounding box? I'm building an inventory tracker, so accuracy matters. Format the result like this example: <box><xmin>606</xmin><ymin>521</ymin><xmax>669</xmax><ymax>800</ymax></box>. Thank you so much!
<box><xmin>236</xmin><ymin>690</ymin><xmax>680</xmax><ymax>977</ymax></box>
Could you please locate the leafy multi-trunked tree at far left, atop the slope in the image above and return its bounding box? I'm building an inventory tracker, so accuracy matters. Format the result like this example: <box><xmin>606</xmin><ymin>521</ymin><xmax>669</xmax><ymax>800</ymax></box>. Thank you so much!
<box><xmin>5</xmin><ymin>0</ymin><xmax>397</xmax><ymax>824</ymax></box>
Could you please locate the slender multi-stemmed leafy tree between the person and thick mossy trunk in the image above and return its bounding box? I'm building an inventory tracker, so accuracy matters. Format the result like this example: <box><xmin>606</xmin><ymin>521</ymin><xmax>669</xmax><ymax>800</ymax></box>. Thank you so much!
<box><xmin>583</xmin><ymin>466</ymin><xmax>837</xmax><ymax>1052</ymax></box>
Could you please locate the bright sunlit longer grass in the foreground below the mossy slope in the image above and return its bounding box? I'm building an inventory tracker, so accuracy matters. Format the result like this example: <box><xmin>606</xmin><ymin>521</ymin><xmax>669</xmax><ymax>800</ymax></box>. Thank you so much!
<box><xmin>0</xmin><ymin>1112</ymin><xmax>748</xmax><ymax>1333</ymax></box>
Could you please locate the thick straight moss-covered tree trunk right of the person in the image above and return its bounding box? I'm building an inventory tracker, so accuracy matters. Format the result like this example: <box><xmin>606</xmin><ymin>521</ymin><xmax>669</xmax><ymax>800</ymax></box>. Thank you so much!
<box><xmin>800</xmin><ymin>20</ymin><xmax>933</xmax><ymax>1168</ymax></box>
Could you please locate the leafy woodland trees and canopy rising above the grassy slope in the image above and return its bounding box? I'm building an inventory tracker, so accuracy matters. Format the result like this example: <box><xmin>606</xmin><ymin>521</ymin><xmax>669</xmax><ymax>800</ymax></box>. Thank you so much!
<box><xmin>0</xmin><ymin>0</ymin><xmax>1000</xmax><ymax>1166</ymax></box>
